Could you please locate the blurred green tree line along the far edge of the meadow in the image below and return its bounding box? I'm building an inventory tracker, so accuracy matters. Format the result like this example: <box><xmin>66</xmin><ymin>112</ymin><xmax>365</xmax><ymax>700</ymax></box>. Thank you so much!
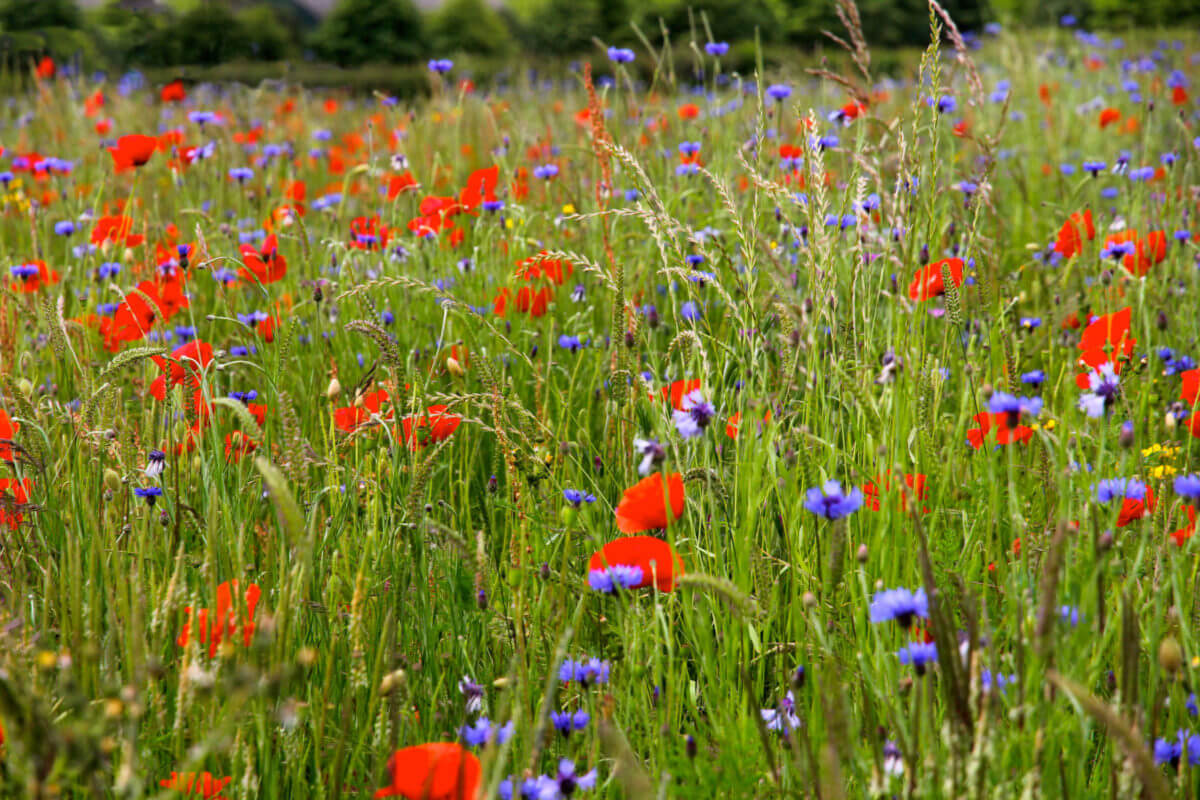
<box><xmin>0</xmin><ymin>0</ymin><xmax>1200</xmax><ymax>73</ymax></box>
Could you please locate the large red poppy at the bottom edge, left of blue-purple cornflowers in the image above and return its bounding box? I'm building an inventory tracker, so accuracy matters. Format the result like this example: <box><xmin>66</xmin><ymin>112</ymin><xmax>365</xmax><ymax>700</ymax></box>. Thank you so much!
<box><xmin>374</xmin><ymin>742</ymin><xmax>482</xmax><ymax>800</ymax></box>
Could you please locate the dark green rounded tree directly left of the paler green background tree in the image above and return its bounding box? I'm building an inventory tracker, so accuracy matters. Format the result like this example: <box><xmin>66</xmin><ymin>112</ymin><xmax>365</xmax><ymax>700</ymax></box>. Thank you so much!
<box><xmin>312</xmin><ymin>0</ymin><xmax>428</xmax><ymax>66</ymax></box>
